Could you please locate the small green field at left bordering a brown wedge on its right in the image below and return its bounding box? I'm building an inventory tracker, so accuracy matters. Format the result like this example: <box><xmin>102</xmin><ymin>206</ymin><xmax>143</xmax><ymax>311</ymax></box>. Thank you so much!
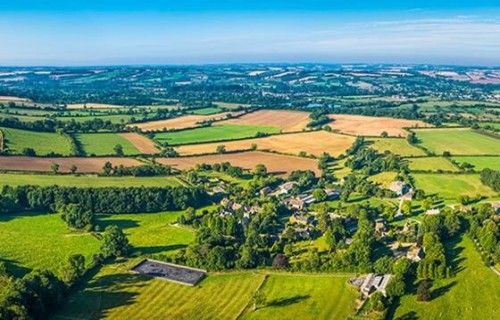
<box><xmin>75</xmin><ymin>133</ymin><xmax>140</xmax><ymax>156</ymax></box>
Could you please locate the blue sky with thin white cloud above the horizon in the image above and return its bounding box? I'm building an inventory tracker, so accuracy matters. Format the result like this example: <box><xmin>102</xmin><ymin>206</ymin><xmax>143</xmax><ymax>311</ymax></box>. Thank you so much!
<box><xmin>0</xmin><ymin>0</ymin><xmax>500</xmax><ymax>66</ymax></box>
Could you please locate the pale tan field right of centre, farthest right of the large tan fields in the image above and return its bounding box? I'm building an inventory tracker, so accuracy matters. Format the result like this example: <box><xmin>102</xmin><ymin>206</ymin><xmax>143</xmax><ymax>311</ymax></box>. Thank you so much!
<box><xmin>330</xmin><ymin>114</ymin><xmax>431</xmax><ymax>137</ymax></box>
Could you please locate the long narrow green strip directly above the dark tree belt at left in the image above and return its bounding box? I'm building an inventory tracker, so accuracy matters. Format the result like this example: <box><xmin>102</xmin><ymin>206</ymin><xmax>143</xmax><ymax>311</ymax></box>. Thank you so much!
<box><xmin>0</xmin><ymin>173</ymin><xmax>183</xmax><ymax>188</ymax></box>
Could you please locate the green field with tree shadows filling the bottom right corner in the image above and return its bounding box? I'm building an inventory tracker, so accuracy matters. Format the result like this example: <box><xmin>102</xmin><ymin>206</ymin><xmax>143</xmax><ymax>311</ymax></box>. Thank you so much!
<box><xmin>389</xmin><ymin>237</ymin><xmax>500</xmax><ymax>320</ymax></box>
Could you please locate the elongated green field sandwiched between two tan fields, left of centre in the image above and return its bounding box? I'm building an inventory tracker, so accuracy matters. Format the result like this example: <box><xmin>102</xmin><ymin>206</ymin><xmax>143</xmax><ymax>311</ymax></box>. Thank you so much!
<box><xmin>155</xmin><ymin>124</ymin><xmax>280</xmax><ymax>145</ymax></box>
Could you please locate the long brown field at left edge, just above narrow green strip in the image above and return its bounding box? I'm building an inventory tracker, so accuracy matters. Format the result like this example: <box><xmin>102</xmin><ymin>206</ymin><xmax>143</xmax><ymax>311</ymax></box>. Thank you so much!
<box><xmin>0</xmin><ymin>157</ymin><xmax>141</xmax><ymax>173</ymax></box>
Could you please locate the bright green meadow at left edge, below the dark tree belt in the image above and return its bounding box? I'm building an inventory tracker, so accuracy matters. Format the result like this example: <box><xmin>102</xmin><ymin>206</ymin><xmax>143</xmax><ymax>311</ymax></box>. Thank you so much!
<box><xmin>0</xmin><ymin>213</ymin><xmax>100</xmax><ymax>276</ymax></box>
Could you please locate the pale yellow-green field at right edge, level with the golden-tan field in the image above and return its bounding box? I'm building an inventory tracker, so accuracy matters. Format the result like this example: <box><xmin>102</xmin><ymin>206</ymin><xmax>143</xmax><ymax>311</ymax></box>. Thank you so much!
<box><xmin>415</xmin><ymin>129</ymin><xmax>500</xmax><ymax>155</ymax></box>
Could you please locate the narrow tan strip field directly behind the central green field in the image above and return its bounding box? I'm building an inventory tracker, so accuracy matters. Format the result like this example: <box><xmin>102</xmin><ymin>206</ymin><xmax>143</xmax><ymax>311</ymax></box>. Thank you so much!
<box><xmin>129</xmin><ymin>112</ymin><xmax>238</xmax><ymax>131</ymax></box>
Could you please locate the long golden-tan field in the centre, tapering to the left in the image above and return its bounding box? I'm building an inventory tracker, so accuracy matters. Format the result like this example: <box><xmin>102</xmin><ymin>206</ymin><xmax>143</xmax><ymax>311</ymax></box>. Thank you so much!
<box><xmin>176</xmin><ymin>131</ymin><xmax>355</xmax><ymax>157</ymax></box>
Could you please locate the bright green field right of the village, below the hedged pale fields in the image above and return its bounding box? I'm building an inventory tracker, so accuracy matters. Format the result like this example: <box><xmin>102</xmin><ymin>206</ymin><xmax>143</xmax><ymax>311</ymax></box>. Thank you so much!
<box><xmin>412</xmin><ymin>173</ymin><xmax>496</xmax><ymax>200</ymax></box>
